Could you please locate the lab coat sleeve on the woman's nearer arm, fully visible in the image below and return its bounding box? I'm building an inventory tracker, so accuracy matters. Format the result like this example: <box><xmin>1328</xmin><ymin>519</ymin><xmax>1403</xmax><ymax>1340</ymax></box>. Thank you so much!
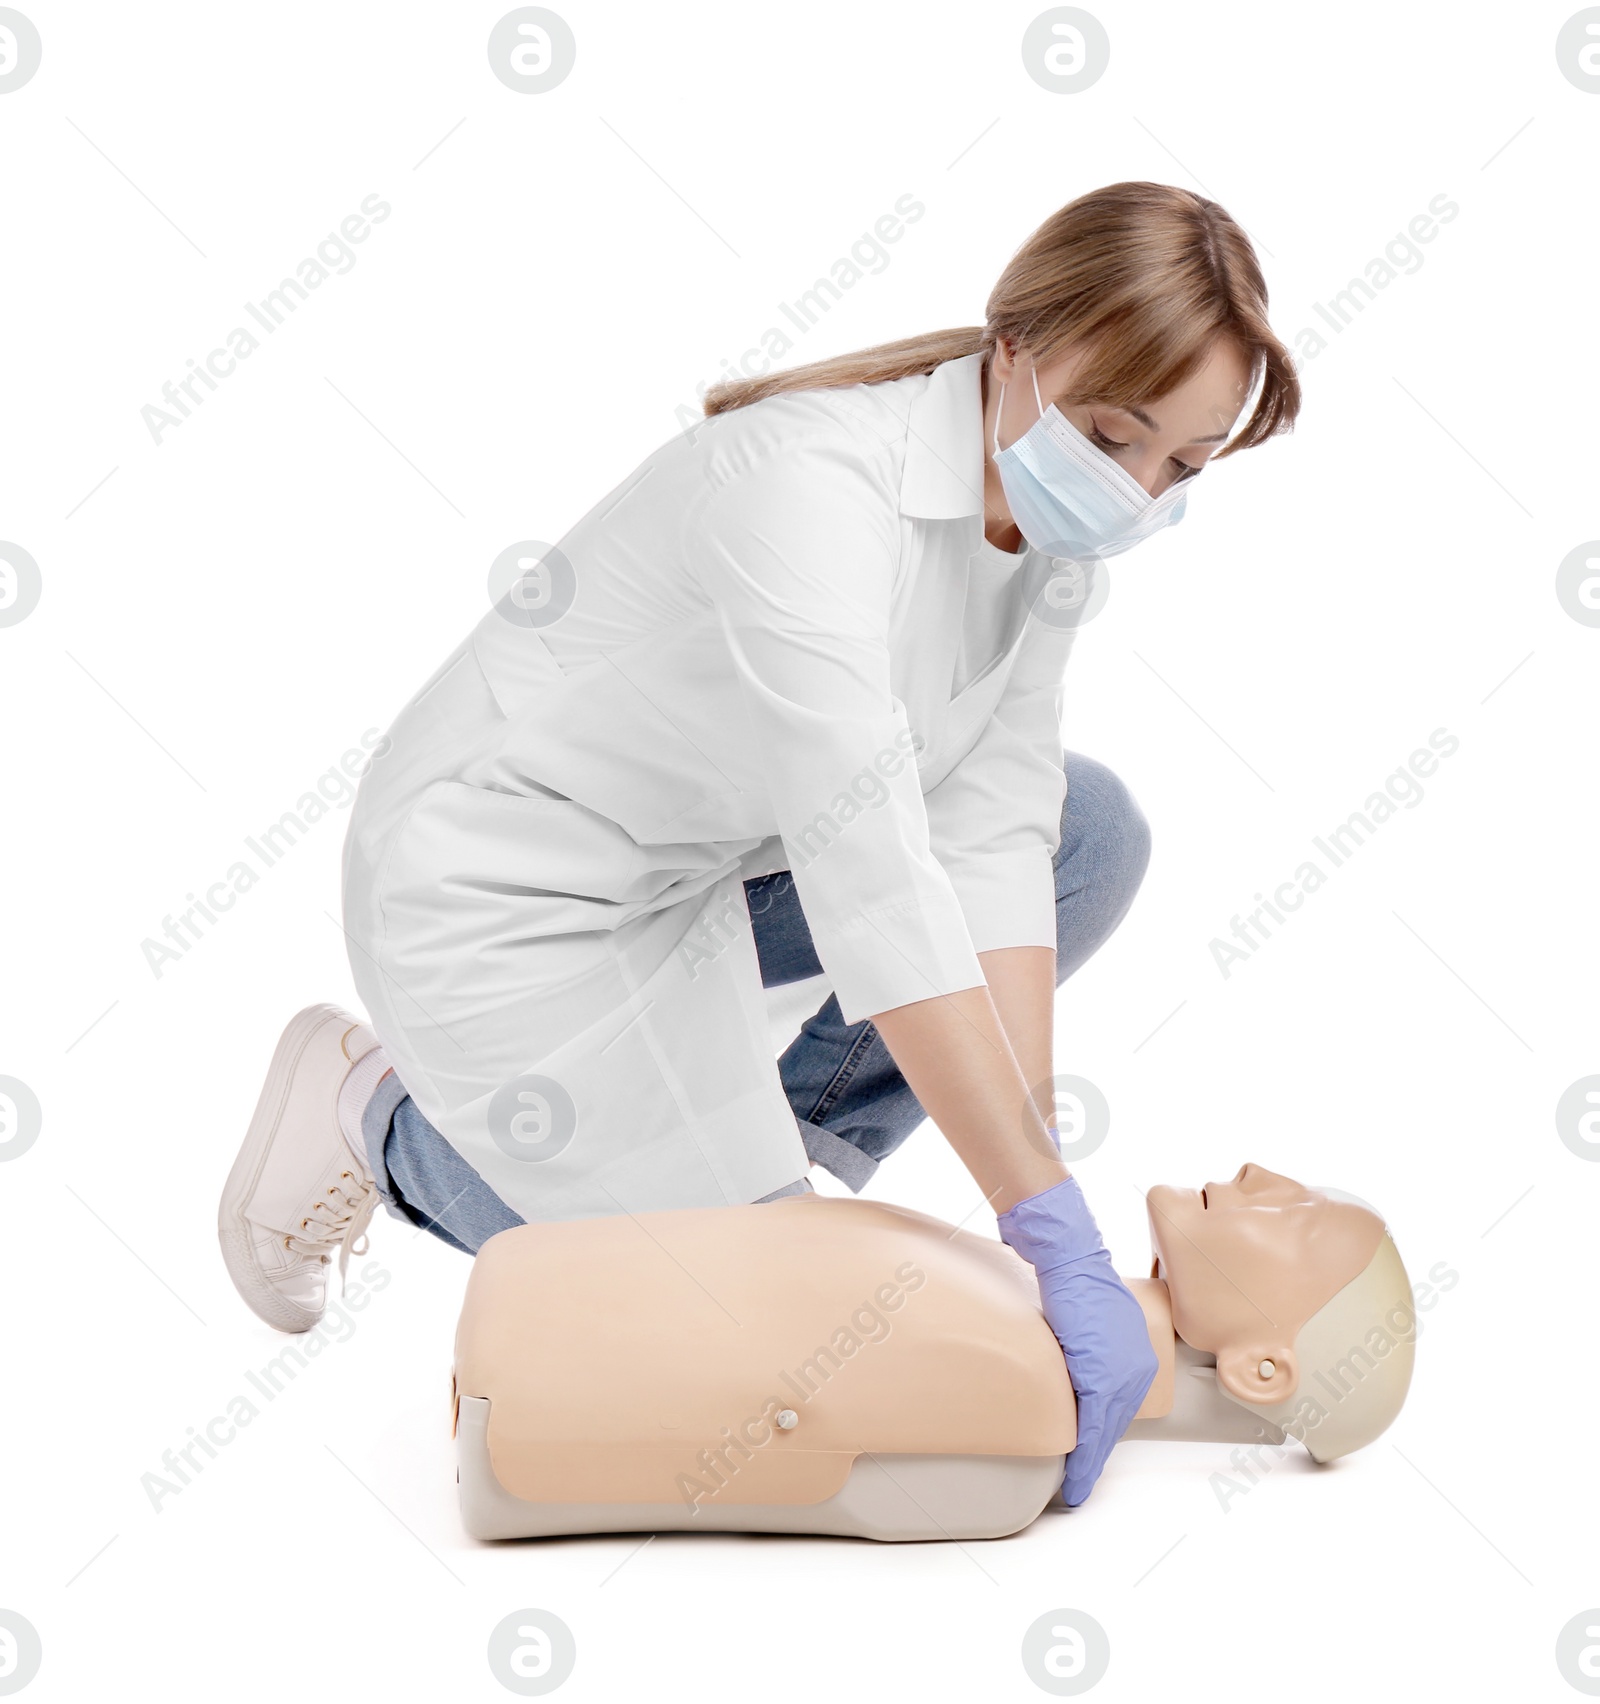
<box><xmin>683</xmin><ymin>433</ymin><xmax>983</xmax><ymax>1024</ymax></box>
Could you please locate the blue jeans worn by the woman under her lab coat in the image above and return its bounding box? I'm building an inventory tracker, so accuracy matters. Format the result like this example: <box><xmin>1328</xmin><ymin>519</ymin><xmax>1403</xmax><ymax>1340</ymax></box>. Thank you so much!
<box><xmin>363</xmin><ymin>751</ymin><xmax>1150</xmax><ymax>1254</ymax></box>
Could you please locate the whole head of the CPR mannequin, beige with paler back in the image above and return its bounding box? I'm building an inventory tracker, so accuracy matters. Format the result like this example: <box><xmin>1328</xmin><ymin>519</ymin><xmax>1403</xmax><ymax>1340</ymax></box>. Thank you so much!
<box><xmin>1145</xmin><ymin>1164</ymin><xmax>1416</xmax><ymax>1460</ymax></box>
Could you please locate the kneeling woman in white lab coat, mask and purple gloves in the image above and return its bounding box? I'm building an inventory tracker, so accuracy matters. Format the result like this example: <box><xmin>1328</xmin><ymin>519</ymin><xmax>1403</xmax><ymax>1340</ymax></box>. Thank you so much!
<box><xmin>220</xmin><ymin>182</ymin><xmax>1298</xmax><ymax>1503</ymax></box>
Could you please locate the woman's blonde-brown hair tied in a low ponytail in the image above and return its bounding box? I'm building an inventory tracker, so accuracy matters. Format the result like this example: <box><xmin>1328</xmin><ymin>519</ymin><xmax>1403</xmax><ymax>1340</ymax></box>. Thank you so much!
<box><xmin>704</xmin><ymin>182</ymin><xmax>1300</xmax><ymax>460</ymax></box>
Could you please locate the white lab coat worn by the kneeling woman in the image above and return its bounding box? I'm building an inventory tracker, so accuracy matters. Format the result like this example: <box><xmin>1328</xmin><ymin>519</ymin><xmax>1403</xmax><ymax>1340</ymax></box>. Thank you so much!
<box><xmin>344</xmin><ymin>354</ymin><xmax>1097</xmax><ymax>1220</ymax></box>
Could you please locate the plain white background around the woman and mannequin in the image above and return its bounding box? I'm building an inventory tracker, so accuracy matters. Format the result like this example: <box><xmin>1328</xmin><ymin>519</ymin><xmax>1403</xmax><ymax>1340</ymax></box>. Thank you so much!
<box><xmin>0</xmin><ymin>0</ymin><xmax>1600</xmax><ymax>1701</ymax></box>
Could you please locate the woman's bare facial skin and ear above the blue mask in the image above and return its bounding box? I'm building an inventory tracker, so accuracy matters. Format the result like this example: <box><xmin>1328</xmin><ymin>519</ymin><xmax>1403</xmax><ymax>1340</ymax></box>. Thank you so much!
<box><xmin>983</xmin><ymin>343</ymin><xmax>1251</xmax><ymax>497</ymax></box>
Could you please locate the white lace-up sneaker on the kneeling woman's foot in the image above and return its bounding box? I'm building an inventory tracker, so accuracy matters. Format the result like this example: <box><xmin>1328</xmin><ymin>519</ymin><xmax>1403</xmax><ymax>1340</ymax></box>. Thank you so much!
<box><xmin>216</xmin><ymin>1005</ymin><xmax>388</xmax><ymax>1331</ymax></box>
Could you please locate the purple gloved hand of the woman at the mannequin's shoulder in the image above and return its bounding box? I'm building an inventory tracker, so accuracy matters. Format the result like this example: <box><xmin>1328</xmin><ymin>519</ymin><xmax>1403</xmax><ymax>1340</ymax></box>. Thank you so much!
<box><xmin>999</xmin><ymin>1177</ymin><xmax>1159</xmax><ymax>1508</ymax></box>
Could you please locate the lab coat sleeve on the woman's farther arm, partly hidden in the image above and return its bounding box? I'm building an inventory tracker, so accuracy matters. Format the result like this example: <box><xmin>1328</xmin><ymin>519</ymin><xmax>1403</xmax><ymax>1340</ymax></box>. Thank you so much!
<box><xmin>927</xmin><ymin>599</ymin><xmax>1073</xmax><ymax>953</ymax></box>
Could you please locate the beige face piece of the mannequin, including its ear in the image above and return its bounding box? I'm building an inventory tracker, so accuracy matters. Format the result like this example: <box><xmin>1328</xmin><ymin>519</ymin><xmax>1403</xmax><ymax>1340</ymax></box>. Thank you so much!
<box><xmin>1145</xmin><ymin>1162</ymin><xmax>1384</xmax><ymax>1406</ymax></box>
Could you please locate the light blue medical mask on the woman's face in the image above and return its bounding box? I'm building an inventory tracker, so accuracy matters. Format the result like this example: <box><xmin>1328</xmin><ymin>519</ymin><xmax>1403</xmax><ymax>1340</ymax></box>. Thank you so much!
<box><xmin>993</xmin><ymin>371</ymin><xmax>1193</xmax><ymax>559</ymax></box>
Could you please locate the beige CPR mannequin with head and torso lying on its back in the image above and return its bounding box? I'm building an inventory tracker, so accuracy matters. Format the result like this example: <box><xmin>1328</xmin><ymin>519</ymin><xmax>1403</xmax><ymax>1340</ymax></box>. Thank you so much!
<box><xmin>453</xmin><ymin>1164</ymin><xmax>1416</xmax><ymax>1540</ymax></box>
